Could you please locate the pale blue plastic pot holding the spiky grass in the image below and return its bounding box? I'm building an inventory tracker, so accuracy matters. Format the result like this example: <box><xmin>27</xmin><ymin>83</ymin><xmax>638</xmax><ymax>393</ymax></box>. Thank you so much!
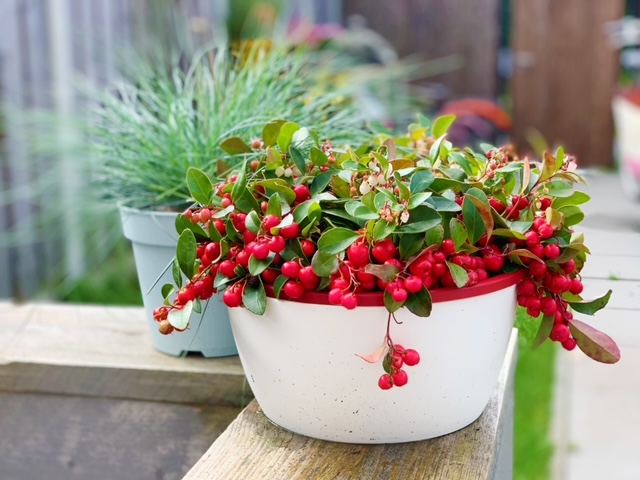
<box><xmin>120</xmin><ymin>207</ymin><xmax>238</xmax><ymax>357</ymax></box>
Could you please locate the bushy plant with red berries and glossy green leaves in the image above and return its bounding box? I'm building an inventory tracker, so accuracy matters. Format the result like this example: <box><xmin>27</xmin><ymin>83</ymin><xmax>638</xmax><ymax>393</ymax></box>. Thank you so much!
<box><xmin>154</xmin><ymin>116</ymin><xmax>620</xmax><ymax>389</ymax></box>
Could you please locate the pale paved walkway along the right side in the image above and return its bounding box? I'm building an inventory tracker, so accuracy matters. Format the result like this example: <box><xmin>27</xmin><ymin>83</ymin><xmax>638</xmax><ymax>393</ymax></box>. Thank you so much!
<box><xmin>554</xmin><ymin>172</ymin><xmax>640</xmax><ymax>480</ymax></box>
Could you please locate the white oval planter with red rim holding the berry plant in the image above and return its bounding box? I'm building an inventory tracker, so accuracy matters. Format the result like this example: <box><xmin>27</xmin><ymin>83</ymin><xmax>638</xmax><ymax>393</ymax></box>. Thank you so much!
<box><xmin>230</xmin><ymin>274</ymin><xmax>521</xmax><ymax>443</ymax></box>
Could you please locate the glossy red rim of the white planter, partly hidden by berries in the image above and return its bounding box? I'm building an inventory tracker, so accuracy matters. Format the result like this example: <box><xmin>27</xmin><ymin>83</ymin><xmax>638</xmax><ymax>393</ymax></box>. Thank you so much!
<box><xmin>264</xmin><ymin>269</ymin><xmax>524</xmax><ymax>307</ymax></box>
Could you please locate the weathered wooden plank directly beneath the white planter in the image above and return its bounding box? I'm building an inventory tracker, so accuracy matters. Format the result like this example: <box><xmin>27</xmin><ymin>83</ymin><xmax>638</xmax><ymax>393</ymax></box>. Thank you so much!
<box><xmin>184</xmin><ymin>331</ymin><xmax>517</xmax><ymax>480</ymax></box>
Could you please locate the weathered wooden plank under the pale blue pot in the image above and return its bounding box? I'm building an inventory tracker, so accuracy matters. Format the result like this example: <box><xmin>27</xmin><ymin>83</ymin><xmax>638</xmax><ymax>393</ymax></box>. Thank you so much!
<box><xmin>0</xmin><ymin>303</ymin><xmax>251</xmax><ymax>405</ymax></box>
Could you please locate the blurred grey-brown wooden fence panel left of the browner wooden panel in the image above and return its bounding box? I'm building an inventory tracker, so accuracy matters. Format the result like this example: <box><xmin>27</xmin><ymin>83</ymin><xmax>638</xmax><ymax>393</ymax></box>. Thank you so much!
<box><xmin>343</xmin><ymin>0</ymin><xmax>500</xmax><ymax>98</ymax></box>
